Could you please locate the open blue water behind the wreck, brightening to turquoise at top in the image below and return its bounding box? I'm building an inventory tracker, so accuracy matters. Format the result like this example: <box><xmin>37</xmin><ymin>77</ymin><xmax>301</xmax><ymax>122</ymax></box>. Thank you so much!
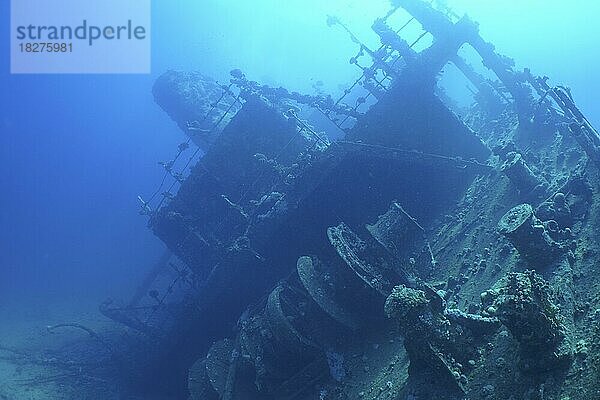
<box><xmin>0</xmin><ymin>0</ymin><xmax>600</xmax><ymax>340</ymax></box>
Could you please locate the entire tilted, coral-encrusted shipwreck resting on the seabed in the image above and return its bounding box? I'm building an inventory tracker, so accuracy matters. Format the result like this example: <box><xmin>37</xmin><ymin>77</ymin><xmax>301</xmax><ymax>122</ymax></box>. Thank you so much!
<box><xmin>90</xmin><ymin>0</ymin><xmax>600</xmax><ymax>400</ymax></box>
